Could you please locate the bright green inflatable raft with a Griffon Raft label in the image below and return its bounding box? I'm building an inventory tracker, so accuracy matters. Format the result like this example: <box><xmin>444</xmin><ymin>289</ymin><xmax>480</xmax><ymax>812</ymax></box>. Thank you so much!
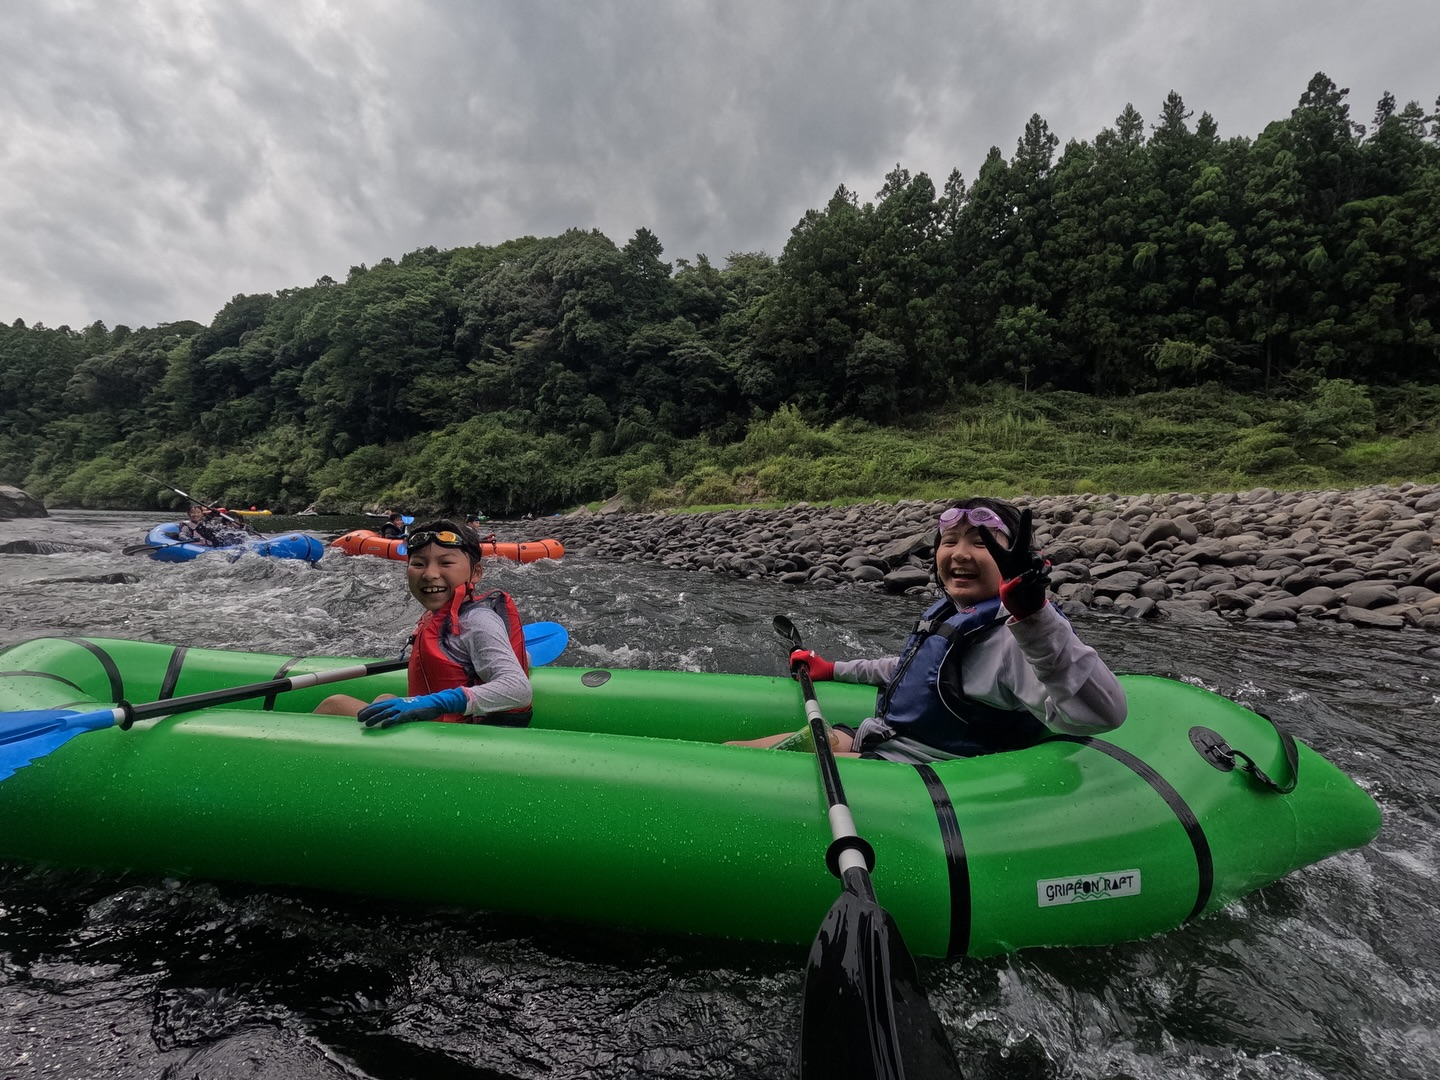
<box><xmin>0</xmin><ymin>638</ymin><xmax>1380</xmax><ymax>956</ymax></box>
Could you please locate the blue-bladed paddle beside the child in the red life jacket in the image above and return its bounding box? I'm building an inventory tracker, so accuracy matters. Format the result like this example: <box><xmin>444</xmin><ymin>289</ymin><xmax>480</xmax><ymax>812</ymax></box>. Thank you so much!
<box><xmin>0</xmin><ymin>622</ymin><xmax>570</xmax><ymax>780</ymax></box>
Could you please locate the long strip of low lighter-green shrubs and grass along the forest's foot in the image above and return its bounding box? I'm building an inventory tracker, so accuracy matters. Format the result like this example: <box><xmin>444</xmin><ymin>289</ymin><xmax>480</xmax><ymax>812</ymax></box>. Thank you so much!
<box><xmin>24</xmin><ymin>380</ymin><xmax>1440</xmax><ymax>517</ymax></box>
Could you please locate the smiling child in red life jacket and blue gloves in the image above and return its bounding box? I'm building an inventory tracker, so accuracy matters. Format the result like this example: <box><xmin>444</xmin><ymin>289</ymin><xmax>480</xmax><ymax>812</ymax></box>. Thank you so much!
<box><xmin>315</xmin><ymin>518</ymin><xmax>530</xmax><ymax>727</ymax></box>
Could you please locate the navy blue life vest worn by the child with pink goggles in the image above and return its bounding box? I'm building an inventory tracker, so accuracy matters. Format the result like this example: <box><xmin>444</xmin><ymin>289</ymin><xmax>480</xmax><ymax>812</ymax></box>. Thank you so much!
<box><xmin>864</xmin><ymin>598</ymin><xmax>1050</xmax><ymax>757</ymax></box>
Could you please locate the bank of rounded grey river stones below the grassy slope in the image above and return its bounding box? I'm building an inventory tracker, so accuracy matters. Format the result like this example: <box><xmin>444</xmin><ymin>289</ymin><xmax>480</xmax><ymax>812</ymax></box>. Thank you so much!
<box><xmin>538</xmin><ymin>484</ymin><xmax>1440</xmax><ymax>631</ymax></box>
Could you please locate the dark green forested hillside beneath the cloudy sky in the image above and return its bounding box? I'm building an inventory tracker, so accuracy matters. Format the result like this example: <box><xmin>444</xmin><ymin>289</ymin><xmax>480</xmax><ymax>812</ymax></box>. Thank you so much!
<box><xmin>0</xmin><ymin>75</ymin><xmax>1440</xmax><ymax>514</ymax></box>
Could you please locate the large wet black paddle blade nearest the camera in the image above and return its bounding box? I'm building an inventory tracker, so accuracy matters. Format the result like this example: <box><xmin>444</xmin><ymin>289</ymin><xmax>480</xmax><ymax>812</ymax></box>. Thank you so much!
<box><xmin>801</xmin><ymin>871</ymin><xmax>962</xmax><ymax>1080</ymax></box>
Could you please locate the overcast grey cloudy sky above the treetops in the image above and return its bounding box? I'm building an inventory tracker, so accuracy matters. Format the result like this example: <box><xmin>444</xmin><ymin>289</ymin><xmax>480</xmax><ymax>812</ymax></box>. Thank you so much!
<box><xmin>0</xmin><ymin>0</ymin><xmax>1440</xmax><ymax>328</ymax></box>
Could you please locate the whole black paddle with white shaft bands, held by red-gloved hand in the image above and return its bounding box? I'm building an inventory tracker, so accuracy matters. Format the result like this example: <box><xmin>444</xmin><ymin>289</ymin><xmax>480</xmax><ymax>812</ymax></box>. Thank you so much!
<box><xmin>773</xmin><ymin>615</ymin><xmax>960</xmax><ymax>1080</ymax></box>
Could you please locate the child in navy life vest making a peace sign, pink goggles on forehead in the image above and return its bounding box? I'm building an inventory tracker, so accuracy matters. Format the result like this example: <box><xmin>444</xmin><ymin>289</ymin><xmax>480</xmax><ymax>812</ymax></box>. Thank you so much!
<box><xmin>733</xmin><ymin>498</ymin><xmax>1126</xmax><ymax>765</ymax></box>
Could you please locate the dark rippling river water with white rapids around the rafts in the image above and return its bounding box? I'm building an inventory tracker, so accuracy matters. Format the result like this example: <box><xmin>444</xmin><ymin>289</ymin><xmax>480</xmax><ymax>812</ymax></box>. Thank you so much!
<box><xmin>0</xmin><ymin>511</ymin><xmax>1440</xmax><ymax>1080</ymax></box>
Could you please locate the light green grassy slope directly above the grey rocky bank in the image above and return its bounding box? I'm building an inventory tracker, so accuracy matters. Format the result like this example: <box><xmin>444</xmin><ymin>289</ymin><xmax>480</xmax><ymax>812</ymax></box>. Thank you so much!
<box><xmin>655</xmin><ymin>380</ymin><xmax>1440</xmax><ymax>508</ymax></box>
